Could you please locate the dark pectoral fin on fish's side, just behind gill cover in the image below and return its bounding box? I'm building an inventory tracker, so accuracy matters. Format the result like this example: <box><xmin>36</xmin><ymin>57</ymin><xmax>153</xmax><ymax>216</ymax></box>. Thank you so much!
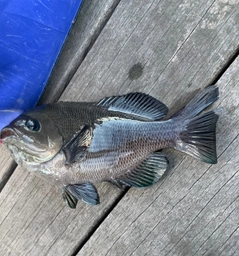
<box><xmin>62</xmin><ymin>125</ymin><xmax>92</xmax><ymax>164</ymax></box>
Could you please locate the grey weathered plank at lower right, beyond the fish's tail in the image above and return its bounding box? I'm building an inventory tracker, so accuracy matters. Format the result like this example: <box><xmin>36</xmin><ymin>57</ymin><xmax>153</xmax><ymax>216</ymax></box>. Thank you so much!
<box><xmin>77</xmin><ymin>57</ymin><xmax>239</xmax><ymax>256</ymax></box>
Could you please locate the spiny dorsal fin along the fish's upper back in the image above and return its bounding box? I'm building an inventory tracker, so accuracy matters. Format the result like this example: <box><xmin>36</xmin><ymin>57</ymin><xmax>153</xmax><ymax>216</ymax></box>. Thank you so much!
<box><xmin>97</xmin><ymin>92</ymin><xmax>168</xmax><ymax>121</ymax></box>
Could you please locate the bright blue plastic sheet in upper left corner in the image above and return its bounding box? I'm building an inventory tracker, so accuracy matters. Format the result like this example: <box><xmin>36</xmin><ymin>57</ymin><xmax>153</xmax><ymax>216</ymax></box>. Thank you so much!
<box><xmin>0</xmin><ymin>0</ymin><xmax>81</xmax><ymax>129</ymax></box>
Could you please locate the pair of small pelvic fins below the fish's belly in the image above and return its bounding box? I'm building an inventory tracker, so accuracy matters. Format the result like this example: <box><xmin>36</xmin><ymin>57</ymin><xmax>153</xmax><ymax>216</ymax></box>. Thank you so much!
<box><xmin>63</xmin><ymin>183</ymin><xmax>100</xmax><ymax>208</ymax></box>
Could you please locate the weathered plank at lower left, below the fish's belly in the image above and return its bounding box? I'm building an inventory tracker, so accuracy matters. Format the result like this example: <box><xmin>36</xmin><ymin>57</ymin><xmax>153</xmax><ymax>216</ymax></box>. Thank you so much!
<box><xmin>0</xmin><ymin>168</ymin><xmax>123</xmax><ymax>255</ymax></box>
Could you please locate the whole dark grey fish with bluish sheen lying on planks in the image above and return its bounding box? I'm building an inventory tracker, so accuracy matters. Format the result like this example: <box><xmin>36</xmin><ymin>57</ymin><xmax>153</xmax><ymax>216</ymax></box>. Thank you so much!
<box><xmin>1</xmin><ymin>85</ymin><xmax>219</xmax><ymax>208</ymax></box>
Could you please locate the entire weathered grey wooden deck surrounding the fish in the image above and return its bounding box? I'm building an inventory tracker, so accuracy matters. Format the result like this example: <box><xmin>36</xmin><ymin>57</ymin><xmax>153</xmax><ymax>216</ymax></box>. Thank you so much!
<box><xmin>0</xmin><ymin>0</ymin><xmax>239</xmax><ymax>256</ymax></box>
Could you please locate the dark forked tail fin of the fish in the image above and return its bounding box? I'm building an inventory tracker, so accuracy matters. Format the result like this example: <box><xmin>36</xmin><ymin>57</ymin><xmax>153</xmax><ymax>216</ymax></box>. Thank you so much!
<box><xmin>173</xmin><ymin>86</ymin><xmax>219</xmax><ymax>164</ymax></box>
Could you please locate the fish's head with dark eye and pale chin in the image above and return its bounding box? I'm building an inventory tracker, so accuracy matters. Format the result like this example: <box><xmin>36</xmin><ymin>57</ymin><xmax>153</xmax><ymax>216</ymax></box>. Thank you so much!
<box><xmin>1</xmin><ymin>112</ymin><xmax>63</xmax><ymax>165</ymax></box>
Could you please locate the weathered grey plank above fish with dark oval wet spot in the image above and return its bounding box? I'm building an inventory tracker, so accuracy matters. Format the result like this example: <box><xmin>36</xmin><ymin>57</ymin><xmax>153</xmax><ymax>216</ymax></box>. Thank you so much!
<box><xmin>62</xmin><ymin>0</ymin><xmax>238</xmax><ymax>105</ymax></box>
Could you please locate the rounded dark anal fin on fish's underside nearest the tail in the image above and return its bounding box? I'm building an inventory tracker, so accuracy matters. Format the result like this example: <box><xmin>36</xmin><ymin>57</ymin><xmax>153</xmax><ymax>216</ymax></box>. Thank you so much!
<box><xmin>117</xmin><ymin>152</ymin><xmax>168</xmax><ymax>188</ymax></box>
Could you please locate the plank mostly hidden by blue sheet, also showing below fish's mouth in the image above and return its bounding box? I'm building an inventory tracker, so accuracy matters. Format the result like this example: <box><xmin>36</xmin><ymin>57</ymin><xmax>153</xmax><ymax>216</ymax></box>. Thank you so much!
<box><xmin>0</xmin><ymin>0</ymin><xmax>119</xmax><ymax>191</ymax></box>
